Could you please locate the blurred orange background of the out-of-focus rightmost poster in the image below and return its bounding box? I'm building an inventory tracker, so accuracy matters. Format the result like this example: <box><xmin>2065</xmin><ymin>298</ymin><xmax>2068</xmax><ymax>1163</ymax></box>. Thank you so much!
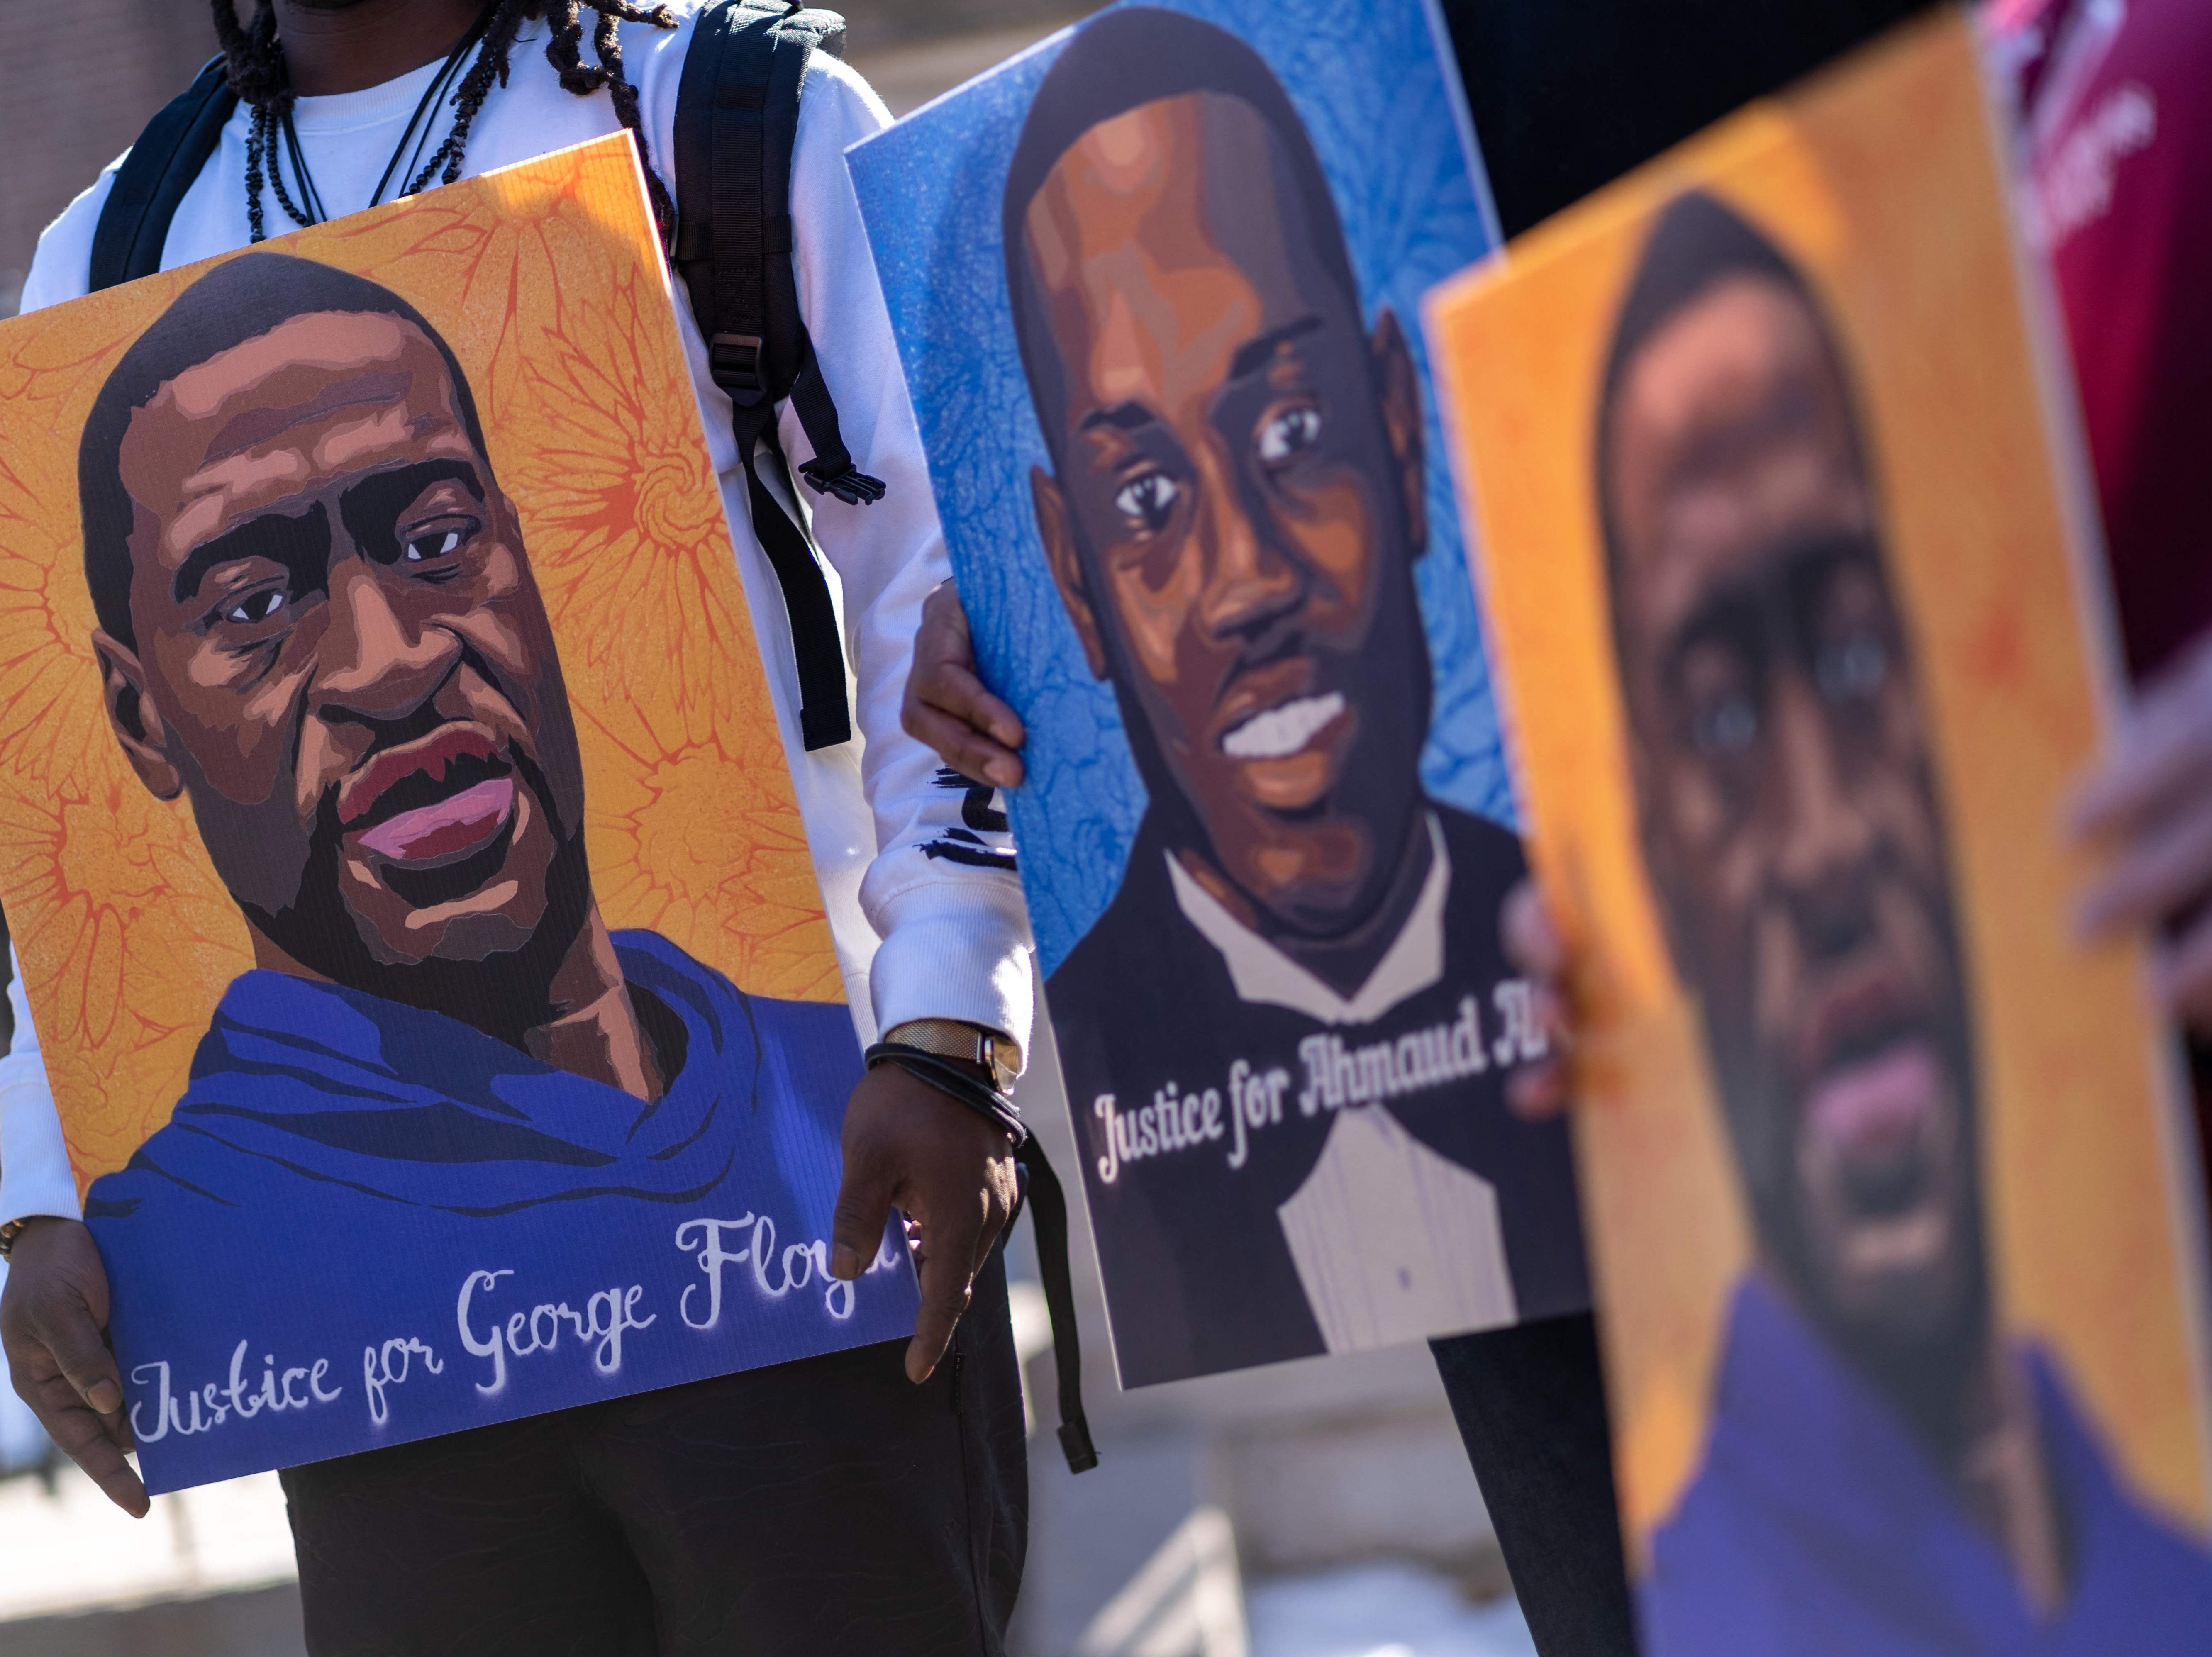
<box><xmin>1429</xmin><ymin>9</ymin><xmax>2212</xmax><ymax>1569</ymax></box>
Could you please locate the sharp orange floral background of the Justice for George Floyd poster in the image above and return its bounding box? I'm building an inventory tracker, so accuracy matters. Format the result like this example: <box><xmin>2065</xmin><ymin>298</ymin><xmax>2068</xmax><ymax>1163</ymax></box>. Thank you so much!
<box><xmin>0</xmin><ymin>135</ymin><xmax>845</xmax><ymax>1190</ymax></box>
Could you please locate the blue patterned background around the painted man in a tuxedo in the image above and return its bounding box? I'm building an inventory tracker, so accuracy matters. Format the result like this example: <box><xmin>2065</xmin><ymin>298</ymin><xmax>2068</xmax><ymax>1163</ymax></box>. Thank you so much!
<box><xmin>847</xmin><ymin>0</ymin><xmax>1513</xmax><ymax>973</ymax></box>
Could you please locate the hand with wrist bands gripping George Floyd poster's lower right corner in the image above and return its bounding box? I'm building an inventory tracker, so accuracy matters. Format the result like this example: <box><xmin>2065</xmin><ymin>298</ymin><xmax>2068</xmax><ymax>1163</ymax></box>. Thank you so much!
<box><xmin>829</xmin><ymin>1064</ymin><xmax>1017</xmax><ymax>1385</ymax></box>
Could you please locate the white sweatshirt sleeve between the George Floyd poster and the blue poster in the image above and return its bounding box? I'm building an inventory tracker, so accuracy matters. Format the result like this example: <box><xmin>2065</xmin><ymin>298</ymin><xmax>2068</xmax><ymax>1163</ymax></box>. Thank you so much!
<box><xmin>779</xmin><ymin>58</ymin><xmax>1033</xmax><ymax>1051</ymax></box>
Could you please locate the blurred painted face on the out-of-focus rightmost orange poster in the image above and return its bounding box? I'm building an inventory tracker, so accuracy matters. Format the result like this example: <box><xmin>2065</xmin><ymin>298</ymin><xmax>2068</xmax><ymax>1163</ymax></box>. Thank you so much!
<box><xmin>1606</xmin><ymin>277</ymin><xmax>1982</xmax><ymax>1340</ymax></box>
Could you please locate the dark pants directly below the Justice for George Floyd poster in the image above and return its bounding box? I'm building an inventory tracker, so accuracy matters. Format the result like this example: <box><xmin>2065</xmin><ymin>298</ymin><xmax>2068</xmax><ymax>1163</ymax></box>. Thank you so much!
<box><xmin>283</xmin><ymin>1252</ymin><xmax>1029</xmax><ymax>1657</ymax></box>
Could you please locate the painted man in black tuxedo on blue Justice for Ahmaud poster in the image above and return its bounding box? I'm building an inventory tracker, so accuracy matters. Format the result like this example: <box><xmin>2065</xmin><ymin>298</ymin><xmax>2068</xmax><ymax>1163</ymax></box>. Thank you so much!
<box><xmin>856</xmin><ymin>7</ymin><xmax>1588</xmax><ymax>1385</ymax></box>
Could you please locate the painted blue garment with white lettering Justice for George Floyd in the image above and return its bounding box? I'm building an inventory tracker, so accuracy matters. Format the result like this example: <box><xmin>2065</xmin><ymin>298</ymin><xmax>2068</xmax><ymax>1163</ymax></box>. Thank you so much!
<box><xmin>84</xmin><ymin>931</ymin><xmax>914</xmax><ymax>1489</ymax></box>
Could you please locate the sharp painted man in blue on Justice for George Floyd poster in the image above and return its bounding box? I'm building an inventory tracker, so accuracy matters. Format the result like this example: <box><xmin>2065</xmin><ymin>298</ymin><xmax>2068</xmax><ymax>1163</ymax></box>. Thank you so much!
<box><xmin>9</xmin><ymin>139</ymin><xmax>909</xmax><ymax>1489</ymax></box>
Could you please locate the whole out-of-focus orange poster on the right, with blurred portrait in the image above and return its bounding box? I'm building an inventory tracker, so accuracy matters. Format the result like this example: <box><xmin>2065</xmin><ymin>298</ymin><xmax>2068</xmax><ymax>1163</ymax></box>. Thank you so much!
<box><xmin>1429</xmin><ymin>9</ymin><xmax>2212</xmax><ymax>1657</ymax></box>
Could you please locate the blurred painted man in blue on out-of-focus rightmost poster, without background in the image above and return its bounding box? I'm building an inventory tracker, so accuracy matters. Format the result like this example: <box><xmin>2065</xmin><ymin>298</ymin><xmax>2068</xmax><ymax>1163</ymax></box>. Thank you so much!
<box><xmin>1597</xmin><ymin>193</ymin><xmax>2212</xmax><ymax>1650</ymax></box>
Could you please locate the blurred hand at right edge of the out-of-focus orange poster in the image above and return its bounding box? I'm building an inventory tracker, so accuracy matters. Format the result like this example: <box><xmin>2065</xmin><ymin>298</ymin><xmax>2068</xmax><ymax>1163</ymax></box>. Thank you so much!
<box><xmin>2071</xmin><ymin>641</ymin><xmax>2212</xmax><ymax>1036</ymax></box>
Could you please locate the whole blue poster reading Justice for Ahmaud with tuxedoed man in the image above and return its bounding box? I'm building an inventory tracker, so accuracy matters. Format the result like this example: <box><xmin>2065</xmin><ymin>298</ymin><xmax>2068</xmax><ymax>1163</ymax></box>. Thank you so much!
<box><xmin>847</xmin><ymin>0</ymin><xmax>1588</xmax><ymax>1385</ymax></box>
